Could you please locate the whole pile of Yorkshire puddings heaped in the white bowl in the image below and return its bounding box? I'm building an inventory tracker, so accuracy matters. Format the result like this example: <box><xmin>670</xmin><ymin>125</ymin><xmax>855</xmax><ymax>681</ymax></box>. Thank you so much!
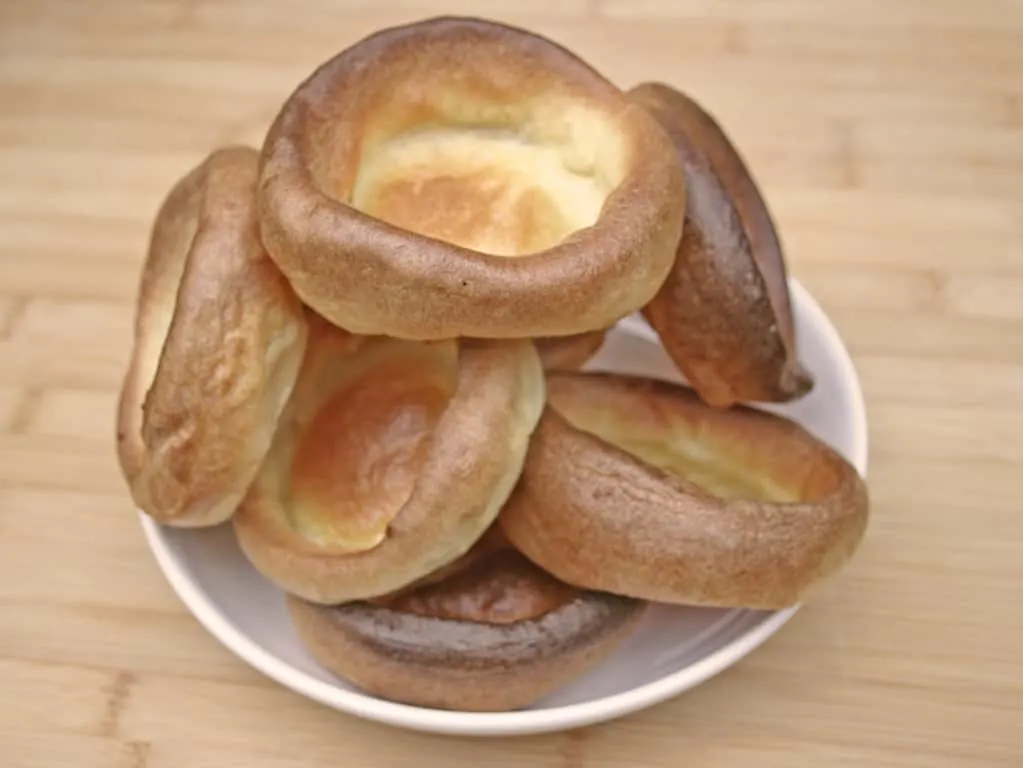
<box><xmin>118</xmin><ymin>17</ymin><xmax>868</xmax><ymax>711</ymax></box>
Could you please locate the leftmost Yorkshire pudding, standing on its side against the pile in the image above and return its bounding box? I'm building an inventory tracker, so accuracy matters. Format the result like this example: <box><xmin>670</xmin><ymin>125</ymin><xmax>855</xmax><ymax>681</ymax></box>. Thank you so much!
<box><xmin>118</xmin><ymin>147</ymin><xmax>307</xmax><ymax>527</ymax></box>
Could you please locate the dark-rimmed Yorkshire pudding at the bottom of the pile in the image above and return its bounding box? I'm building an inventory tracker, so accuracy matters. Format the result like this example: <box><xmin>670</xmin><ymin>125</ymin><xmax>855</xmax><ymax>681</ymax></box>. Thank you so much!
<box><xmin>288</xmin><ymin>535</ymin><xmax>644</xmax><ymax>711</ymax></box>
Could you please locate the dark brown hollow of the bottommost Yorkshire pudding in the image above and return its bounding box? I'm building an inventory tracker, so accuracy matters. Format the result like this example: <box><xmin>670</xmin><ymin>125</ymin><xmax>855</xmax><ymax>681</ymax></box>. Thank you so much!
<box><xmin>384</xmin><ymin>548</ymin><xmax>579</xmax><ymax>624</ymax></box>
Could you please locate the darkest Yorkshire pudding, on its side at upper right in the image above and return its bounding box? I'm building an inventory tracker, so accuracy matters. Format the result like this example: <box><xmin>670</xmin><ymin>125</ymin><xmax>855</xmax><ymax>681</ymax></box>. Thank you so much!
<box><xmin>629</xmin><ymin>83</ymin><xmax>813</xmax><ymax>406</ymax></box>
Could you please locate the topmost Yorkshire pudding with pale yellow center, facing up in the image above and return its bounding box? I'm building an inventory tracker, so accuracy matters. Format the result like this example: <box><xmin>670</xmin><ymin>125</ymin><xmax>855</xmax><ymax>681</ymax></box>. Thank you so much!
<box><xmin>260</xmin><ymin>17</ymin><xmax>685</xmax><ymax>340</ymax></box>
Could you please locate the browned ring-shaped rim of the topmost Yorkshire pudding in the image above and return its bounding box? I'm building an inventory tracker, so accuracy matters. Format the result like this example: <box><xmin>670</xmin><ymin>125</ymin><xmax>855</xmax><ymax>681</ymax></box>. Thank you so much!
<box><xmin>259</xmin><ymin>17</ymin><xmax>685</xmax><ymax>340</ymax></box>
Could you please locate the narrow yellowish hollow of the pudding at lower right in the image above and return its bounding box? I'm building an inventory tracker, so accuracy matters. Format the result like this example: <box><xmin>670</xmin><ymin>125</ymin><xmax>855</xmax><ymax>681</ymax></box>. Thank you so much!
<box><xmin>548</xmin><ymin>386</ymin><xmax>801</xmax><ymax>502</ymax></box>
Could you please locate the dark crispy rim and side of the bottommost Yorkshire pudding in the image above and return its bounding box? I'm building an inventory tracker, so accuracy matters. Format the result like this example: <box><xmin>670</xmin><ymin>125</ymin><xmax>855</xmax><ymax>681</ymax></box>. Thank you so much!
<box><xmin>287</xmin><ymin>580</ymin><xmax>646</xmax><ymax>712</ymax></box>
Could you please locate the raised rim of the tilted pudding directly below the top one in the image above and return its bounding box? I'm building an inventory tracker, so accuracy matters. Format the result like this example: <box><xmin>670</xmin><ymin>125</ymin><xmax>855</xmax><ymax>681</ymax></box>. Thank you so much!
<box><xmin>233</xmin><ymin>340</ymin><xmax>545</xmax><ymax>603</ymax></box>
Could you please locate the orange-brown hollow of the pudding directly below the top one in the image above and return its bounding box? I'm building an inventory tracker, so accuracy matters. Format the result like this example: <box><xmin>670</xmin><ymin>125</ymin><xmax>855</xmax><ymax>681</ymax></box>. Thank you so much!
<box><xmin>290</xmin><ymin>343</ymin><xmax>456</xmax><ymax>552</ymax></box>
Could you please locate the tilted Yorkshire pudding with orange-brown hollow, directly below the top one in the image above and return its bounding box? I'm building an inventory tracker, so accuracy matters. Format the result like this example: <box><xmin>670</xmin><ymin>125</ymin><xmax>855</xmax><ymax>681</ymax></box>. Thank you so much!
<box><xmin>234</xmin><ymin>318</ymin><xmax>544</xmax><ymax>603</ymax></box>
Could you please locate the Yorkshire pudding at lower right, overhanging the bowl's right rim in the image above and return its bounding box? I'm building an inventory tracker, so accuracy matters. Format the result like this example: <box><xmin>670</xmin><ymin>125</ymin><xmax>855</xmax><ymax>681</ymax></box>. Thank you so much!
<box><xmin>498</xmin><ymin>373</ymin><xmax>868</xmax><ymax>608</ymax></box>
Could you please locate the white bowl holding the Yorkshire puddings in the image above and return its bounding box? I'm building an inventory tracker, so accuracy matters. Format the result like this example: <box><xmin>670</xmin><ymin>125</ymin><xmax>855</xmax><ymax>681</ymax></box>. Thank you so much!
<box><xmin>141</xmin><ymin>281</ymin><xmax>866</xmax><ymax>735</ymax></box>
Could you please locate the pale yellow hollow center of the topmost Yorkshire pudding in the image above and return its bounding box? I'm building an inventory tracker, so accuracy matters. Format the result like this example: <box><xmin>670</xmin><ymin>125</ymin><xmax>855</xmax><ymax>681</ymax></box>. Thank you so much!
<box><xmin>352</xmin><ymin>126</ymin><xmax>611</xmax><ymax>257</ymax></box>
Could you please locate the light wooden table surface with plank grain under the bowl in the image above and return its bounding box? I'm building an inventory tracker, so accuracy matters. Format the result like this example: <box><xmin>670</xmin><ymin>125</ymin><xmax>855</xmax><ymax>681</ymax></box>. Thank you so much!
<box><xmin>0</xmin><ymin>0</ymin><xmax>1023</xmax><ymax>768</ymax></box>
